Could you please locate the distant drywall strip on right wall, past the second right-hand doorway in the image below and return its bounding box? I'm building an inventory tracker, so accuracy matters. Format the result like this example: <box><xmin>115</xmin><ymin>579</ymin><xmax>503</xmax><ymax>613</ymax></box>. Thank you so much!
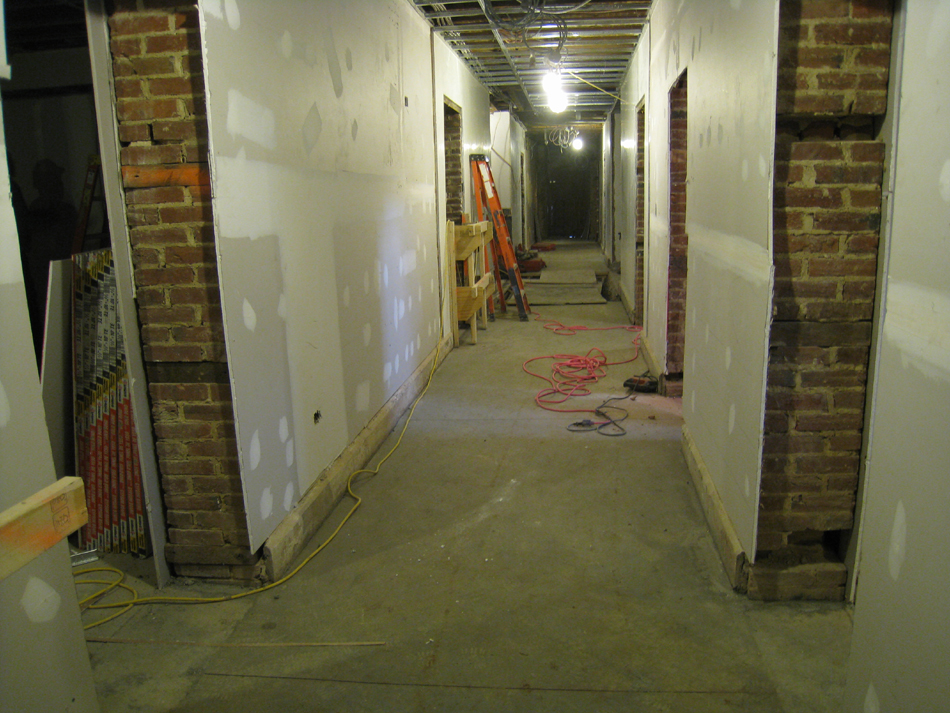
<box><xmin>618</xmin><ymin>24</ymin><xmax>650</xmax><ymax>318</ymax></box>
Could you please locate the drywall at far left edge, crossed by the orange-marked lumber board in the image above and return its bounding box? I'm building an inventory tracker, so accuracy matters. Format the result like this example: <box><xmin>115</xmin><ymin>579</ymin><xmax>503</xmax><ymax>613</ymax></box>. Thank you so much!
<box><xmin>0</xmin><ymin>103</ymin><xmax>99</xmax><ymax>713</ymax></box>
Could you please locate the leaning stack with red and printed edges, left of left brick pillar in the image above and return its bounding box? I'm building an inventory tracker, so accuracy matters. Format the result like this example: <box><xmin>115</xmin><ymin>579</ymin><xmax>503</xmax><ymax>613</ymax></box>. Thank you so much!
<box><xmin>73</xmin><ymin>249</ymin><xmax>148</xmax><ymax>555</ymax></box>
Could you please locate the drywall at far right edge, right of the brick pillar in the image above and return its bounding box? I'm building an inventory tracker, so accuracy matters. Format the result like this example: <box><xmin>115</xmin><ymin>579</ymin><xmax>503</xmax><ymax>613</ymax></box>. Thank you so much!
<box><xmin>844</xmin><ymin>2</ymin><xmax>950</xmax><ymax>713</ymax></box>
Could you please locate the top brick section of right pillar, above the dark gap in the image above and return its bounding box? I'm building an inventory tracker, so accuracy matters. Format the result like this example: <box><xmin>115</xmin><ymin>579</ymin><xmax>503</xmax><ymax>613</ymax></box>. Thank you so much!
<box><xmin>778</xmin><ymin>0</ymin><xmax>893</xmax><ymax>116</ymax></box>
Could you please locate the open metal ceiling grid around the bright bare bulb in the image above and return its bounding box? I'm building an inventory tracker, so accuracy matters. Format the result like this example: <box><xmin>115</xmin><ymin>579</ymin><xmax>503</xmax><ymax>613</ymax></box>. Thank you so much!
<box><xmin>411</xmin><ymin>0</ymin><xmax>652</xmax><ymax>127</ymax></box>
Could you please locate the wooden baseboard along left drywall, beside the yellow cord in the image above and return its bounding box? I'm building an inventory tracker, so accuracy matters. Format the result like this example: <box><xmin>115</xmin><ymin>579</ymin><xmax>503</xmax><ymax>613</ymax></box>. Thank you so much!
<box><xmin>263</xmin><ymin>334</ymin><xmax>452</xmax><ymax>582</ymax></box>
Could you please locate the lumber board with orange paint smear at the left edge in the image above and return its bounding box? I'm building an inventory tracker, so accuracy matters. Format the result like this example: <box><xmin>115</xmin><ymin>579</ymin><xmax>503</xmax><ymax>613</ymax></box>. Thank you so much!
<box><xmin>0</xmin><ymin>476</ymin><xmax>87</xmax><ymax>579</ymax></box>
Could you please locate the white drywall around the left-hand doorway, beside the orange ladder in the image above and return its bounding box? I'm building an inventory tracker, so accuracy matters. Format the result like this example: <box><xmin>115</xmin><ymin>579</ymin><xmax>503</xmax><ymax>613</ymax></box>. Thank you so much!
<box><xmin>431</xmin><ymin>33</ymin><xmax>491</xmax><ymax>333</ymax></box>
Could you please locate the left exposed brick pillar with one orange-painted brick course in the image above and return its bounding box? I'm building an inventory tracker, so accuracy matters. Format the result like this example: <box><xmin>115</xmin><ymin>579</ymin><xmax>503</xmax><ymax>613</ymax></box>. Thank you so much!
<box><xmin>109</xmin><ymin>0</ymin><xmax>256</xmax><ymax>579</ymax></box>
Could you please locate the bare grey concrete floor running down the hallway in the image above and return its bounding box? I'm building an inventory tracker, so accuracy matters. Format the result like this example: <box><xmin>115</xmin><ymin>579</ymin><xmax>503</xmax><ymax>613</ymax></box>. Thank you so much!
<box><xmin>87</xmin><ymin>302</ymin><xmax>851</xmax><ymax>713</ymax></box>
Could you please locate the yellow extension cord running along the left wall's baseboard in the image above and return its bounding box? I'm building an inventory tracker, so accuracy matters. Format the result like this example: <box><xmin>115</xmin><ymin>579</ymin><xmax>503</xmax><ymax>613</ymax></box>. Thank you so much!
<box><xmin>73</xmin><ymin>332</ymin><xmax>443</xmax><ymax>630</ymax></box>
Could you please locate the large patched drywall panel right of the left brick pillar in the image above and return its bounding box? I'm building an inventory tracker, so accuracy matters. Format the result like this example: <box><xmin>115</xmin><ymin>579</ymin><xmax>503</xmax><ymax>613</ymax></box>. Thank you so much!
<box><xmin>200</xmin><ymin>0</ymin><xmax>440</xmax><ymax>549</ymax></box>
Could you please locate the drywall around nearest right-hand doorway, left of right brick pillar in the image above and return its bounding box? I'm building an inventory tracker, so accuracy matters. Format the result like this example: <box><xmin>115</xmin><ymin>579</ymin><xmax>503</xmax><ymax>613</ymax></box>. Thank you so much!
<box><xmin>646</xmin><ymin>0</ymin><xmax>778</xmax><ymax>557</ymax></box>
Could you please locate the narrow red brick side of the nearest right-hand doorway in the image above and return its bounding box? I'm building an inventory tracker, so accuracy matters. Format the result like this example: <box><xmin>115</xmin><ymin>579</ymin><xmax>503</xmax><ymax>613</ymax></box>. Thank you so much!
<box><xmin>666</xmin><ymin>72</ymin><xmax>688</xmax><ymax>386</ymax></box>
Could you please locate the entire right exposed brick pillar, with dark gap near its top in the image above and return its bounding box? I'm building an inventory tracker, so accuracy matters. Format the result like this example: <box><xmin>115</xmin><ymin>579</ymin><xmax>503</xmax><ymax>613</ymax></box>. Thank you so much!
<box><xmin>750</xmin><ymin>0</ymin><xmax>891</xmax><ymax>599</ymax></box>
